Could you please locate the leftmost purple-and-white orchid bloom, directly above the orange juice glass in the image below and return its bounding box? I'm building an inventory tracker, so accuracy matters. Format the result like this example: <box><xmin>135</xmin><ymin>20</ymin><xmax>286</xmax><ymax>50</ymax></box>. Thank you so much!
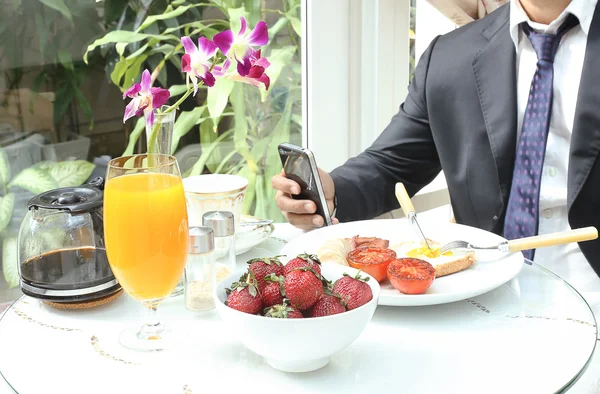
<box><xmin>123</xmin><ymin>70</ymin><xmax>171</xmax><ymax>126</ymax></box>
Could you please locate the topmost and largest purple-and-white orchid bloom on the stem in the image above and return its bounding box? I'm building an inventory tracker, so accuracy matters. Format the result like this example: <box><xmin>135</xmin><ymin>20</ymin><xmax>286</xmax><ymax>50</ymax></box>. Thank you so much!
<box><xmin>213</xmin><ymin>17</ymin><xmax>269</xmax><ymax>77</ymax></box>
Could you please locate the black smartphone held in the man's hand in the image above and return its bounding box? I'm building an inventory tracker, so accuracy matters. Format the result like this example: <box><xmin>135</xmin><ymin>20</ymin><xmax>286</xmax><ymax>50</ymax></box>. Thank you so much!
<box><xmin>279</xmin><ymin>145</ymin><xmax>330</xmax><ymax>224</ymax></box>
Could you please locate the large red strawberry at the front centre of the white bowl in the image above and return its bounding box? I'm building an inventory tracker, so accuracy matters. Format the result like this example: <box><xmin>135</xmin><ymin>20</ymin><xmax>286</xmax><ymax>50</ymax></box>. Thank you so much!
<box><xmin>283</xmin><ymin>267</ymin><xmax>323</xmax><ymax>310</ymax></box>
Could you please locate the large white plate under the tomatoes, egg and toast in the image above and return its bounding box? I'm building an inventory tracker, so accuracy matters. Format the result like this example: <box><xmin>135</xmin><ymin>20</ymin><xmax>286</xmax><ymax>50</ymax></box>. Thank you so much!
<box><xmin>281</xmin><ymin>219</ymin><xmax>524</xmax><ymax>306</ymax></box>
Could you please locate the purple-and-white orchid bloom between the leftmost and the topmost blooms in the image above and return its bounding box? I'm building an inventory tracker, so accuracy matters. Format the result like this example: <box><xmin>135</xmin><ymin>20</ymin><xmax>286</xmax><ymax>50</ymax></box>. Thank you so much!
<box><xmin>181</xmin><ymin>37</ymin><xmax>220</xmax><ymax>96</ymax></box>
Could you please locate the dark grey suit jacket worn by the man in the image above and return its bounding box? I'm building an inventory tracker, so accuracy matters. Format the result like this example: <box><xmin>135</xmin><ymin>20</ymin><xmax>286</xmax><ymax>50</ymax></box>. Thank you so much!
<box><xmin>331</xmin><ymin>5</ymin><xmax>600</xmax><ymax>275</ymax></box>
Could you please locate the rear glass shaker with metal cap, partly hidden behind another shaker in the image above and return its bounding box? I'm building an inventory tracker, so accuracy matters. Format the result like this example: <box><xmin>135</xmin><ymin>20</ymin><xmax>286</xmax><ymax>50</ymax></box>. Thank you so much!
<box><xmin>202</xmin><ymin>211</ymin><xmax>236</xmax><ymax>283</ymax></box>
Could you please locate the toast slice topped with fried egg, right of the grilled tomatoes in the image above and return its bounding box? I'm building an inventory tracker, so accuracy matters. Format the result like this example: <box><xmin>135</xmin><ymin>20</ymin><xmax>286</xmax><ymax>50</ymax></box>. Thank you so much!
<box><xmin>390</xmin><ymin>238</ymin><xmax>476</xmax><ymax>278</ymax></box>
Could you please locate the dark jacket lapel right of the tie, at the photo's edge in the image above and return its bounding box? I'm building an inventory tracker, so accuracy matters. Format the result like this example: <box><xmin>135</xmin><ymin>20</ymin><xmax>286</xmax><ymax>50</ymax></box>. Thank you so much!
<box><xmin>567</xmin><ymin>6</ymin><xmax>600</xmax><ymax>209</ymax></box>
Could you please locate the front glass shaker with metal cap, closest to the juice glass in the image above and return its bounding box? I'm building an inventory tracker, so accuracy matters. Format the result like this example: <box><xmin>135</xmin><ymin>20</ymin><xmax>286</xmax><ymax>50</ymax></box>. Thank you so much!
<box><xmin>184</xmin><ymin>227</ymin><xmax>215</xmax><ymax>311</ymax></box>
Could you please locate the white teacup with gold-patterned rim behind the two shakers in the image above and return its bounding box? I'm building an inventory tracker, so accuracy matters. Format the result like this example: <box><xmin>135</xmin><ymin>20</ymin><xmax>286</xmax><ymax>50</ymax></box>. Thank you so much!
<box><xmin>183</xmin><ymin>174</ymin><xmax>248</xmax><ymax>233</ymax></box>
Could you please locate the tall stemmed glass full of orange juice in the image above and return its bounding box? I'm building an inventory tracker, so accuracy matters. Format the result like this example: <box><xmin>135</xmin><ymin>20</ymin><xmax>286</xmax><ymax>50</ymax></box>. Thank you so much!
<box><xmin>104</xmin><ymin>154</ymin><xmax>188</xmax><ymax>350</ymax></box>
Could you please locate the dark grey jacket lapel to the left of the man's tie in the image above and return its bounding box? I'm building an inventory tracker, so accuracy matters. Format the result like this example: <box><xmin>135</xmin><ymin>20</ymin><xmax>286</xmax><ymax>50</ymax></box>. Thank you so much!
<box><xmin>473</xmin><ymin>5</ymin><xmax>517</xmax><ymax>201</ymax></box>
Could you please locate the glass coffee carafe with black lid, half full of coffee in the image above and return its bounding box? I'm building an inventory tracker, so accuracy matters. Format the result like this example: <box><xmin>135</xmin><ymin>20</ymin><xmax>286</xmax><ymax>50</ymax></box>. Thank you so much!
<box><xmin>18</xmin><ymin>178</ymin><xmax>121</xmax><ymax>303</ymax></box>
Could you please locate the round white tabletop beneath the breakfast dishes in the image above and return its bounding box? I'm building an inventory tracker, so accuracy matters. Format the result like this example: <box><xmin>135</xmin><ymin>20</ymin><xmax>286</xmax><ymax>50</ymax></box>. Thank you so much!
<box><xmin>0</xmin><ymin>225</ymin><xmax>598</xmax><ymax>394</ymax></box>
